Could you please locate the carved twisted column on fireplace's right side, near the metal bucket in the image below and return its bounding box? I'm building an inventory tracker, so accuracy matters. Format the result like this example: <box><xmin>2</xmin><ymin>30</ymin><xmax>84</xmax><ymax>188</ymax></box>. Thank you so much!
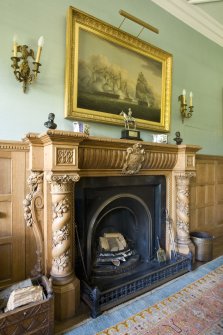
<box><xmin>176</xmin><ymin>172</ymin><xmax>195</xmax><ymax>254</ymax></box>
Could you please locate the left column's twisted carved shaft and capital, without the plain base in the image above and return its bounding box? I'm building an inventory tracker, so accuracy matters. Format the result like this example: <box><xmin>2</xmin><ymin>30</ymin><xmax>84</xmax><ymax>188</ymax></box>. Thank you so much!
<box><xmin>46</xmin><ymin>173</ymin><xmax>79</xmax><ymax>284</ymax></box>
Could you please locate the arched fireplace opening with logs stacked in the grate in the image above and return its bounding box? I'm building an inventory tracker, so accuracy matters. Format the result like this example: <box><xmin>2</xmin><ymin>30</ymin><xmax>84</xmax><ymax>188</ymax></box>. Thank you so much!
<box><xmin>88</xmin><ymin>193</ymin><xmax>153</xmax><ymax>280</ymax></box>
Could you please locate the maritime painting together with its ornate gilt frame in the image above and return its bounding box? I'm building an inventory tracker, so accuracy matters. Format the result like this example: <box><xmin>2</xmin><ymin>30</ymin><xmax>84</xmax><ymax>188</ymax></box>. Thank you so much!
<box><xmin>65</xmin><ymin>7</ymin><xmax>172</xmax><ymax>132</ymax></box>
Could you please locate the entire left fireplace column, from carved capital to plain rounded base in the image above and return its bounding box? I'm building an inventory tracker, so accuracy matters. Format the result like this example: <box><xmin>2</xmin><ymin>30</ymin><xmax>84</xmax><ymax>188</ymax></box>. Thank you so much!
<box><xmin>46</xmin><ymin>172</ymin><xmax>80</xmax><ymax>320</ymax></box>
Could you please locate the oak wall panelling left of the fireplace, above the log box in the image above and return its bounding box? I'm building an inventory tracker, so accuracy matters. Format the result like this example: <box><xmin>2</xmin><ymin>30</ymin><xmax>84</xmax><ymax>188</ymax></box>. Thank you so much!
<box><xmin>0</xmin><ymin>148</ymin><xmax>26</xmax><ymax>287</ymax></box>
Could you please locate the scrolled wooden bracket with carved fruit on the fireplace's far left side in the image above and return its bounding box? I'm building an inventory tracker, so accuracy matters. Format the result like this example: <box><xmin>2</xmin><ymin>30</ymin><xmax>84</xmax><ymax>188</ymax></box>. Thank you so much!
<box><xmin>23</xmin><ymin>171</ymin><xmax>43</xmax><ymax>276</ymax></box>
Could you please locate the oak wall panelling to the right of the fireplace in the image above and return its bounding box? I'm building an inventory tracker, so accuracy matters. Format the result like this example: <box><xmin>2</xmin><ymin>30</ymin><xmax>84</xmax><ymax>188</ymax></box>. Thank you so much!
<box><xmin>190</xmin><ymin>155</ymin><xmax>223</xmax><ymax>237</ymax></box>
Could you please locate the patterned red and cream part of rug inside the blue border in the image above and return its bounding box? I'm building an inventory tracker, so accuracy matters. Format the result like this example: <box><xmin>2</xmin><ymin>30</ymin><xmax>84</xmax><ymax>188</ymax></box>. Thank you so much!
<box><xmin>98</xmin><ymin>265</ymin><xmax>223</xmax><ymax>335</ymax></box>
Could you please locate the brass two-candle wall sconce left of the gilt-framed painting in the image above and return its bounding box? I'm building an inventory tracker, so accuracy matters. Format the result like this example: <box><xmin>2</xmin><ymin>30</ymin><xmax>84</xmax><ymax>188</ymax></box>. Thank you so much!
<box><xmin>11</xmin><ymin>36</ymin><xmax>44</xmax><ymax>93</ymax></box>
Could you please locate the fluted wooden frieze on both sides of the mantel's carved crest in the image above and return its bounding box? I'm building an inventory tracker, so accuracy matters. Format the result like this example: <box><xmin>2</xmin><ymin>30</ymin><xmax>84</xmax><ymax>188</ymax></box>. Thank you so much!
<box><xmin>79</xmin><ymin>147</ymin><xmax>177</xmax><ymax>170</ymax></box>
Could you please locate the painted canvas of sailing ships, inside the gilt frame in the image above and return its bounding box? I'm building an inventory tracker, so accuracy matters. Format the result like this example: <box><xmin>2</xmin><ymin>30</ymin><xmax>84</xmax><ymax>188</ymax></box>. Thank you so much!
<box><xmin>77</xmin><ymin>29</ymin><xmax>162</xmax><ymax>123</ymax></box>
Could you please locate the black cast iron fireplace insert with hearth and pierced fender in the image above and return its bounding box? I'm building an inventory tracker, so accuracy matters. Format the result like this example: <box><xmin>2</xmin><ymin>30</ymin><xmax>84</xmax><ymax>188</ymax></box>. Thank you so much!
<box><xmin>75</xmin><ymin>176</ymin><xmax>191</xmax><ymax>317</ymax></box>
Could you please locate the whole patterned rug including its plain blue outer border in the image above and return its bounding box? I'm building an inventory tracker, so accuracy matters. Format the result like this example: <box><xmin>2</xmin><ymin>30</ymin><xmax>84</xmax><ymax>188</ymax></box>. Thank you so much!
<box><xmin>63</xmin><ymin>256</ymin><xmax>223</xmax><ymax>335</ymax></box>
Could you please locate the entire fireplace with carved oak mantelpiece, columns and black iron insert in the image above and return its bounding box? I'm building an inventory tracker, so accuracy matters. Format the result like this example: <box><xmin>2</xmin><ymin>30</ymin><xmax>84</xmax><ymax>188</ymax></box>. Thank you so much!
<box><xmin>24</xmin><ymin>130</ymin><xmax>200</xmax><ymax>320</ymax></box>
